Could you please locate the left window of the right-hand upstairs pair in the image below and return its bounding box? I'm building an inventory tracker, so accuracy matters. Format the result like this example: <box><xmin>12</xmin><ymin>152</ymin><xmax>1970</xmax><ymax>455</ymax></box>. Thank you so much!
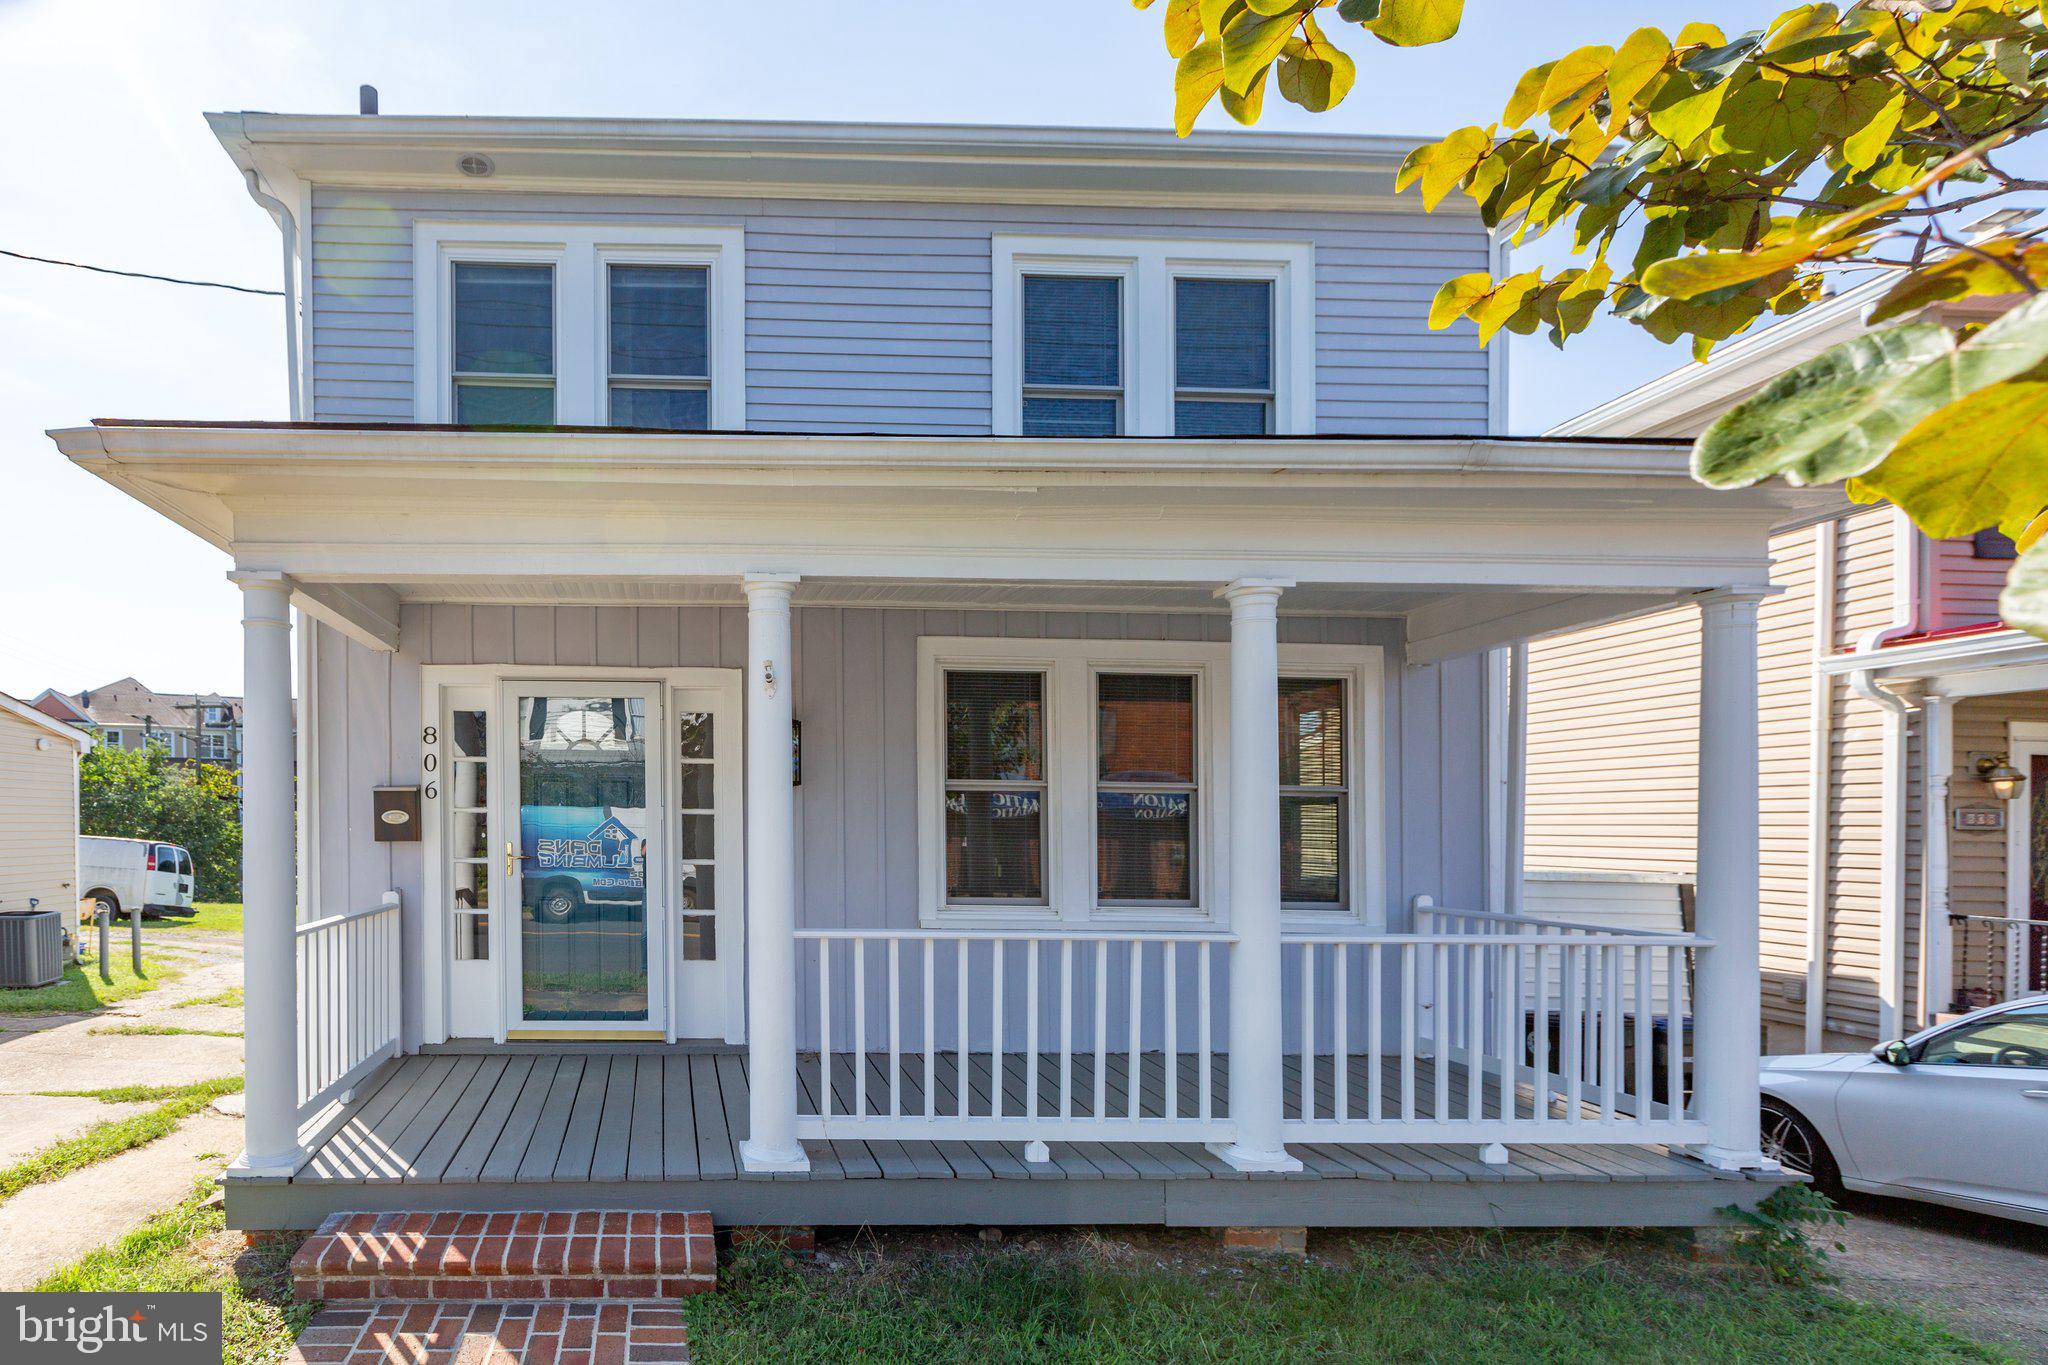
<box><xmin>1022</xmin><ymin>274</ymin><xmax>1124</xmax><ymax>436</ymax></box>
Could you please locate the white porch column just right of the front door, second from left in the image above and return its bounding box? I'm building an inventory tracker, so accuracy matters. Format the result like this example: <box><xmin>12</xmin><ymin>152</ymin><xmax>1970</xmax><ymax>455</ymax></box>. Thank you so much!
<box><xmin>739</xmin><ymin>573</ymin><xmax>811</xmax><ymax>1171</ymax></box>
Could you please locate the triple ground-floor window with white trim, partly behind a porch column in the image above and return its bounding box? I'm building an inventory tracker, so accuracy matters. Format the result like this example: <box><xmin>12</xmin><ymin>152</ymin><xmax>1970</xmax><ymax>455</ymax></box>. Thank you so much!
<box><xmin>918</xmin><ymin>636</ymin><xmax>1384</xmax><ymax>931</ymax></box>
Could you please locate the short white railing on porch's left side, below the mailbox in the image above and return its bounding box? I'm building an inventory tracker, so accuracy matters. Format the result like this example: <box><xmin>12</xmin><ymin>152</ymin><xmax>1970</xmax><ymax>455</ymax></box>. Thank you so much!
<box><xmin>297</xmin><ymin>890</ymin><xmax>399</xmax><ymax>1117</ymax></box>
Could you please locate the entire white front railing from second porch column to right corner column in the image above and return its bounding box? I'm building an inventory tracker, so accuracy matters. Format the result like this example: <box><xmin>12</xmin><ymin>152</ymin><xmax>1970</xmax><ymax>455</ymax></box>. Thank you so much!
<box><xmin>797</xmin><ymin>905</ymin><xmax>1706</xmax><ymax>1144</ymax></box>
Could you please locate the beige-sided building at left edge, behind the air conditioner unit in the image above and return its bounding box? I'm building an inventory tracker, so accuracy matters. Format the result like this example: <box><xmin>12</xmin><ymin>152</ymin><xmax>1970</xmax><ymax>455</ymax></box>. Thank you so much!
<box><xmin>0</xmin><ymin>692</ymin><xmax>92</xmax><ymax>923</ymax></box>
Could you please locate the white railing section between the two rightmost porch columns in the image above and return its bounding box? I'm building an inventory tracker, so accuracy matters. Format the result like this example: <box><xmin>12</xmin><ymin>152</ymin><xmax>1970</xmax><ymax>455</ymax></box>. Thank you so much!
<box><xmin>1284</xmin><ymin>905</ymin><xmax>1706</xmax><ymax>1144</ymax></box>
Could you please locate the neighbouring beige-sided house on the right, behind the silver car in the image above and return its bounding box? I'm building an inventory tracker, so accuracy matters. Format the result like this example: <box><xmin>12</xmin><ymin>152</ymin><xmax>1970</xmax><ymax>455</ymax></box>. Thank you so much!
<box><xmin>1524</xmin><ymin>280</ymin><xmax>2048</xmax><ymax>1052</ymax></box>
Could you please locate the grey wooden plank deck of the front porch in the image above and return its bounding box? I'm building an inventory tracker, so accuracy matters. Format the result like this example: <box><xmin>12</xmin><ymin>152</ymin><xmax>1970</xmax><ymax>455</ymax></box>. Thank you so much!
<box><xmin>227</xmin><ymin>1044</ymin><xmax>1780</xmax><ymax>1228</ymax></box>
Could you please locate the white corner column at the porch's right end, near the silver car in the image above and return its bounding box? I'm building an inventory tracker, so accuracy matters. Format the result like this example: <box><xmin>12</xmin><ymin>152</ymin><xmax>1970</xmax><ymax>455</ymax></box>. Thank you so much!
<box><xmin>1692</xmin><ymin>589</ymin><xmax>1763</xmax><ymax>1171</ymax></box>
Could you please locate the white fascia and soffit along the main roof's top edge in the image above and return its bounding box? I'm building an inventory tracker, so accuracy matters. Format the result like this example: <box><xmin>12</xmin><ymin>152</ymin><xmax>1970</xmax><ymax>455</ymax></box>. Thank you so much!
<box><xmin>207</xmin><ymin>113</ymin><xmax>1473</xmax><ymax>215</ymax></box>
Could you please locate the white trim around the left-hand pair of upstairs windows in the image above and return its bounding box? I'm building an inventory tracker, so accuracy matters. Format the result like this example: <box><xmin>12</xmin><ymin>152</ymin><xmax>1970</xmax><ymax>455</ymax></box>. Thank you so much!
<box><xmin>412</xmin><ymin>221</ymin><xmax>748</xmax><ymax>432</ymax></box>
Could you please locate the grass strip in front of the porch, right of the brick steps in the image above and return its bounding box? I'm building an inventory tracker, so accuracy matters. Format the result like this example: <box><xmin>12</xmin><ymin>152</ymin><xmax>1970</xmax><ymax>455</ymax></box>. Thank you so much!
<box><xmin>684</xmin><ymin>1234</ymin><xmax>2009</xmax><ymax>1365</ymax></box>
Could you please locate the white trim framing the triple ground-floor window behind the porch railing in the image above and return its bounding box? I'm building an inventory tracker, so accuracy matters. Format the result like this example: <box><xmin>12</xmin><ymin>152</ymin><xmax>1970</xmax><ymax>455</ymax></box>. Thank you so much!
<box><xmin>918</xmin><ymin>636</ymin><xmax>1386</xmax><ymax>933</ymax></box>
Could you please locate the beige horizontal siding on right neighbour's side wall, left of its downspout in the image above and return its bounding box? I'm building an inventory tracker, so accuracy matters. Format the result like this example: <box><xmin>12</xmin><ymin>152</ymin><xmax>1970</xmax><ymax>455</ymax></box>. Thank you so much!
<box><xmin>1524</xmin><ymin>528</ymin><xmax>1815</xmax><ymax>1023</ymax></box>
